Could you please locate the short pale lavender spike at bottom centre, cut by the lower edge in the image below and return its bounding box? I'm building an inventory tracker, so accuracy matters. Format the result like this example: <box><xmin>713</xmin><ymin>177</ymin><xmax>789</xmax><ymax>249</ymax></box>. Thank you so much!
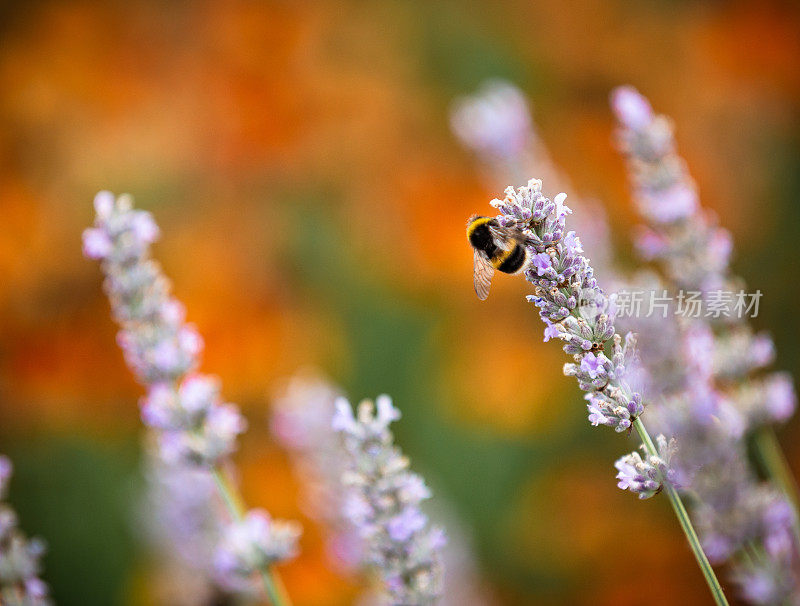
<box><xmin>333</xmin><ymin>395</ymin><xmax>445</xmax><ymax>606</ymax></box>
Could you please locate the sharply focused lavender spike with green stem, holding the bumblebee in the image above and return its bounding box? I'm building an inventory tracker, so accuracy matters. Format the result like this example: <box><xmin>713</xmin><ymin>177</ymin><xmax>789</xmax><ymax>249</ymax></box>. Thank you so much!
<box><xmin>484</xmin><ymin>179</ymin><xmax>727</xmax><ymax>605</ymax></box>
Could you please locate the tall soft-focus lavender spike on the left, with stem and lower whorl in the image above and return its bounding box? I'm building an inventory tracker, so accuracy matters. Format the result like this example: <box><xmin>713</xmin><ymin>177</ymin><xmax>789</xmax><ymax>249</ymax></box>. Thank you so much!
<box><xmin>83</xmin><ymin>191</ymin><xmax>299</xmax><ymax>606</ymax></box>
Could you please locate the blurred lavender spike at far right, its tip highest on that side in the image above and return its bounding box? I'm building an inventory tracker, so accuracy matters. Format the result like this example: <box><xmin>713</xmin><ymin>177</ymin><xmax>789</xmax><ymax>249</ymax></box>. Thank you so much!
<box><xmin>612</xmin><ymin>87</ymin><xmax>794</xmax><ymax>428</ymax></box>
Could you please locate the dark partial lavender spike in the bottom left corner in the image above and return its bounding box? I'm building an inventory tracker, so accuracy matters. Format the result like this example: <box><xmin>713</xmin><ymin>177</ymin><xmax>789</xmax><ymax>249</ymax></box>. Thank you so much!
<box><xmin>0</xmin><ymin>455</ymin><xmax>51</xmax><ymax>606</ymax></box>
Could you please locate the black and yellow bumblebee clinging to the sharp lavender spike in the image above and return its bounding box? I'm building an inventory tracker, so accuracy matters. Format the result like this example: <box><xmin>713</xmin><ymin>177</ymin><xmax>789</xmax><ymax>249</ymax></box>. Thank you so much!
<box><xmin>467</xmin><ymin>215</ymin><xmax>528</xmax><ymax>301</ymax></box>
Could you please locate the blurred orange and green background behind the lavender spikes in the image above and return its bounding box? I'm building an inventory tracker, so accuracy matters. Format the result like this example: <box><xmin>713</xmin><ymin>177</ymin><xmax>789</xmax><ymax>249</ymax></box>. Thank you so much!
<box><xmin>0</xmin><ymin>0</ymin><xmax>800</xmax><ymax>606</ymax></box>
